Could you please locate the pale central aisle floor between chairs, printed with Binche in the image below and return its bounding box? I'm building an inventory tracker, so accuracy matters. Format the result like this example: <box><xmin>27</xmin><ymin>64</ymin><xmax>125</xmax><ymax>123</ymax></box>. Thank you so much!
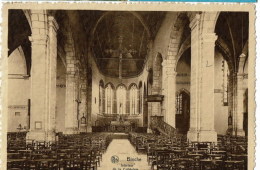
<box><xmin>98</xmin><ymin>139</ymin><xmax>151</xmax><ymax>170</ymax></box>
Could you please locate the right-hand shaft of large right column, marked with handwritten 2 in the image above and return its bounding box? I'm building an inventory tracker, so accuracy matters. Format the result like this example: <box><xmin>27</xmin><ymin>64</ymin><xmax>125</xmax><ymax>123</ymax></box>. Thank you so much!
<box><xmin>199</xmin><ymin>33</ymin><xmax>217</xmax><ymax>142</ymax></box>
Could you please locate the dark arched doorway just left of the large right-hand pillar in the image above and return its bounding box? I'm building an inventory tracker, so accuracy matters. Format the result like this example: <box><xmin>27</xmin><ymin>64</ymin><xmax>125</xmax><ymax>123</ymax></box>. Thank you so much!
<box><xmin>175</xmin><ymin>90</ymin><xmax>190</xmax><ymax>134</ymax></box>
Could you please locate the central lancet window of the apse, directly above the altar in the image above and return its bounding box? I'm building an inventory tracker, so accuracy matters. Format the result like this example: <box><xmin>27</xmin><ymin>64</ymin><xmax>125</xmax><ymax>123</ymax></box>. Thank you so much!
<box><xmin>116</xmin><ymin>85</ymin><xmax>126</xmax><ymax>114</ymax></box>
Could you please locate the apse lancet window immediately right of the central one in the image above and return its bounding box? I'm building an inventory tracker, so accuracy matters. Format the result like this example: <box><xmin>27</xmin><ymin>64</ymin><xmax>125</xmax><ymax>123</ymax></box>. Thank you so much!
<box><xmin>130</xmin><ymin>85</ymin><xmax>138</xmax><ymax>114</ymax></box>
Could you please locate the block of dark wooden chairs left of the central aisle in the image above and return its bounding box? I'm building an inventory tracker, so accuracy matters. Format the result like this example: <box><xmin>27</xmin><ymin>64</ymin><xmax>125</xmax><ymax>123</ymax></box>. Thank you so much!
<box><xmin>7</xmin><ymin>133</ymin><xmax>111</xmax><ymax>169</ymax></box>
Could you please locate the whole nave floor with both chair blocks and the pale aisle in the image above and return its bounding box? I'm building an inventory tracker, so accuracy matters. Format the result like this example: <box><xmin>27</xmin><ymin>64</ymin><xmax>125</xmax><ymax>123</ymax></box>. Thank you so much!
<box><xmin>7</xmin><ymin>132</ymin><xmax>247</xmax><ymax>170</ymax></box>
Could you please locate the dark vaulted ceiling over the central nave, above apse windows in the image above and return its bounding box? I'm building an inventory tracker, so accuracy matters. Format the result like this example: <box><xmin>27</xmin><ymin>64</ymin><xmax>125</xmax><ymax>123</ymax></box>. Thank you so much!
<box><xmin>79</xmin><ymin>11</ymin><xmax>165</xmax><ymax>77</ymax></box>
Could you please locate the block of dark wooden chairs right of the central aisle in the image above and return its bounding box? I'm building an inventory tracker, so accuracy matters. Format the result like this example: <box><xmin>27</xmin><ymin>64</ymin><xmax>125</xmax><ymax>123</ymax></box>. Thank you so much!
<box><xmin>129</xmin><ymin>133</ymin><xmax>247</xmax><ymax>170</ymax></box>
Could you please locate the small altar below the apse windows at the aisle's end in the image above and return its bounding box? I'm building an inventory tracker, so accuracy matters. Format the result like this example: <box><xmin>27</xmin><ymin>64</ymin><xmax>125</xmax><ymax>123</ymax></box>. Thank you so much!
<box><xmin>110</xmin><ymin>121</ymin><xmax>132</xmax><ymax>132</ymax></box>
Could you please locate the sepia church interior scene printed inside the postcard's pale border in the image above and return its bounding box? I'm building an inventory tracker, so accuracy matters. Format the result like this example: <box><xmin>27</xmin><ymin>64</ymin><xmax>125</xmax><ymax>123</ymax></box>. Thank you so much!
<box><xmin>7</xmin><ymin>9</ymin><xmax>249</xmax><ymax>170</ymax></box>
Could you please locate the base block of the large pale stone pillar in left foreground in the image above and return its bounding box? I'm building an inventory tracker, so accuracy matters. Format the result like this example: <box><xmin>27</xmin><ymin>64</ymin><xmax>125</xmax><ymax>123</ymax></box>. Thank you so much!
<box><xmin>26</xmin><ymin>131</ymin><xmax>55</xmax><ymax>142</ymax></box>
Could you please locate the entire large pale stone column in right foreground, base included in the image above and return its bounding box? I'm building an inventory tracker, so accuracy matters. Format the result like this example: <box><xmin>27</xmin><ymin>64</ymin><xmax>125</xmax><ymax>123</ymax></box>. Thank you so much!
<box><xmin>188</xmin><ymin>15</ymin><xmax>217</xmax><ymax>142</ymax></box>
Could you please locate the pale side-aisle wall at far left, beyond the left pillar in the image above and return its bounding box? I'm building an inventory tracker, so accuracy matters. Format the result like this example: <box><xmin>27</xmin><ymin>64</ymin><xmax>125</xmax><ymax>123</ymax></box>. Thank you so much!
<box><xmin>7</xmin><ymin>47</ymin><xmax>31</xmax><ymax>132</ymax></box>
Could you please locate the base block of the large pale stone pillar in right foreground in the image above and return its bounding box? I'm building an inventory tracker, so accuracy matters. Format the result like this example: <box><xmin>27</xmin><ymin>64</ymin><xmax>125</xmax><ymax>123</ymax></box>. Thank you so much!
<box><xmin>187</xmin><ymin>130</ymin><xmax>218</xmax><ymax>142</ymax></box>
